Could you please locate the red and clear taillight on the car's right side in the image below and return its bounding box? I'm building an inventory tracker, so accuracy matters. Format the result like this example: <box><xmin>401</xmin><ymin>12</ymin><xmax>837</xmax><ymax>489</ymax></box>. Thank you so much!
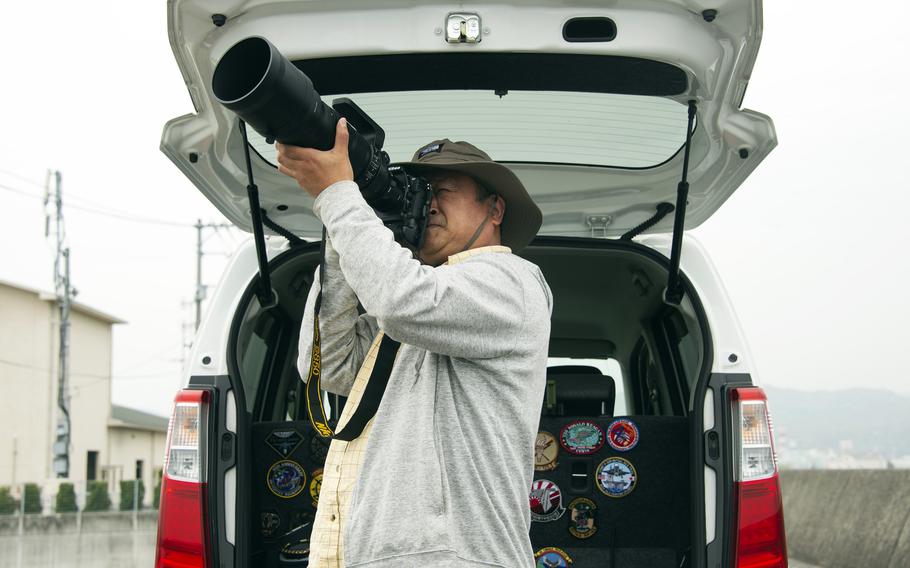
<box><xmin>730</xmin><ymin>387</ymin><xmax>787</xmax><ymax>568</ymax></box>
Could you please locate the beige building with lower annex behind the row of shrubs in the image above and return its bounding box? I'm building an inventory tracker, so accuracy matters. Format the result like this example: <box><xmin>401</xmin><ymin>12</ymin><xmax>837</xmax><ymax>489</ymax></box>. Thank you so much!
<box><xmin>0</xmin><ymin>281</ymin><xmax>167</xmax><ymax>502</ymax></box>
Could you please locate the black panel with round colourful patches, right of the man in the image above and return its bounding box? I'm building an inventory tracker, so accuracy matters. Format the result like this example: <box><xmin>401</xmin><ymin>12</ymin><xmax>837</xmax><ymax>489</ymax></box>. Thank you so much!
<box><xmin>529</xmin><ymin>416</ymin><xmax>690</xmax><ymax>568</ymax></box>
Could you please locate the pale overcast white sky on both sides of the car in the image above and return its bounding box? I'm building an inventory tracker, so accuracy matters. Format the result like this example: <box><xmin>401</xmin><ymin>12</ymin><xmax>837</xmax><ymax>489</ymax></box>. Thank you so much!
<box><xmin>0</xmin><ymin>0</ymin><xmax>910</xmax><ymax>415</ymax></box>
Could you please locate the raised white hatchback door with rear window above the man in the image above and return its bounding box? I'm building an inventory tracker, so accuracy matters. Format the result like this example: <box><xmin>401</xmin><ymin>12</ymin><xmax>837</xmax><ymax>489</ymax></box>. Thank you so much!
<box><xmin>161</xmin><ymin>0</ymin><xmax>776</xmax><ymax>242</ymax></box>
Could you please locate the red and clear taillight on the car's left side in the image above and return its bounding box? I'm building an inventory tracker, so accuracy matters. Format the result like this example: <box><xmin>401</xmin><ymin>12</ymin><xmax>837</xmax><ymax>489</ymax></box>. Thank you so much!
<box><xmin>155</xmin><ymin>390</ymin><xmax>209</xmax><ymax>568</ymax></box>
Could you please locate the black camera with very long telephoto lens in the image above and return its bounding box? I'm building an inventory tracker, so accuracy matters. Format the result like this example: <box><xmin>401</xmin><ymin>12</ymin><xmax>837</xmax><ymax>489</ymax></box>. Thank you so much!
<box><xmin>212</xmin><ymin>36</ymin><xmax>433</xmax><ymax>249</ymax></box>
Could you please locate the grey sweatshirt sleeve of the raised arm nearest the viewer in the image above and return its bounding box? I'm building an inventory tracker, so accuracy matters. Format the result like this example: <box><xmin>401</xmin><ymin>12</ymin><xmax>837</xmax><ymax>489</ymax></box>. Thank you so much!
<box><xmin>314</xmin><ymin>181</ymin><xmax>529</xmax><ymax>358</ymax></box>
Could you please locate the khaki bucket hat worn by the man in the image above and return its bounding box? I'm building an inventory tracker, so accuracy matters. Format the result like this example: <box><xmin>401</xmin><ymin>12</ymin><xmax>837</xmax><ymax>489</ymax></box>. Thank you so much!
<box><xmin>392</xmin><ymin>138</ymin><xmax>543</xmax><ymax>252</ymax></box>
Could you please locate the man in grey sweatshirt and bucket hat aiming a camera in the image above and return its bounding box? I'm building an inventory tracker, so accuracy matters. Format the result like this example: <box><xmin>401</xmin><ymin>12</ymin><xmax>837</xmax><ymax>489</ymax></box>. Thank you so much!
<box><xmin>278</xmin><ymin>119</ymin><xmax>552</xmax><ymax>568</ymax></box>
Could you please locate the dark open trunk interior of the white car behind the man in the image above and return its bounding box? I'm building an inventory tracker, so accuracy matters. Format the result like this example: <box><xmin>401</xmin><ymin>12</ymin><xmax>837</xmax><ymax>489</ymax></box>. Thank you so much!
<box><xmin>231</xmin><ymin>238</ymin><xmax>711</xmax><ymax>568</ymax></box>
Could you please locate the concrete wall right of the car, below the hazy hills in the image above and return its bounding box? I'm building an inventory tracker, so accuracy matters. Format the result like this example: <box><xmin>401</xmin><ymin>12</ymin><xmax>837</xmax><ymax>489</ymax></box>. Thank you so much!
<box><xmin>781</xmin><ymin>470</ymin><xmax>910</xmax><ymax>568</ymax></box>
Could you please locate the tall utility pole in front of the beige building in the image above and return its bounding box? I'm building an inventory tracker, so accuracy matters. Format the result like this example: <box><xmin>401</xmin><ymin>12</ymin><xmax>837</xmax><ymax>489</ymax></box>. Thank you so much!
<box><xmin>44</xmin><ymin>171</ymin><xmax>75</xmax><ymax>478</ymax></box>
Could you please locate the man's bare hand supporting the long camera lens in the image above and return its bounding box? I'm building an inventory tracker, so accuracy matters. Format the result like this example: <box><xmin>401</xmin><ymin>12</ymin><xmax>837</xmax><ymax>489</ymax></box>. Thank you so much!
<box><xmin>275</xmin><ymin>118</ymin><xmax>354</xmax><ymax>198</ymax></box>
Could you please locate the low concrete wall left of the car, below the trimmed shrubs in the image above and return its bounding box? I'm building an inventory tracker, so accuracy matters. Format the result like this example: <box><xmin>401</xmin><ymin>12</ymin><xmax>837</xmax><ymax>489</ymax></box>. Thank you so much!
<box><xmin>0</xmin><ymin>511</ymin><xmax>158</xmax><ymax>568</ymax></box>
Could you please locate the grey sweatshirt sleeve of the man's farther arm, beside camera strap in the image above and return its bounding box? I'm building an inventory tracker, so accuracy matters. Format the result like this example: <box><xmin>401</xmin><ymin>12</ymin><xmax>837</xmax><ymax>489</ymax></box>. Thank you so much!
<box><xmin>297</xmin><ymin>235</ymin><xmax>378</xmax><ymax>396</ymax></box>
